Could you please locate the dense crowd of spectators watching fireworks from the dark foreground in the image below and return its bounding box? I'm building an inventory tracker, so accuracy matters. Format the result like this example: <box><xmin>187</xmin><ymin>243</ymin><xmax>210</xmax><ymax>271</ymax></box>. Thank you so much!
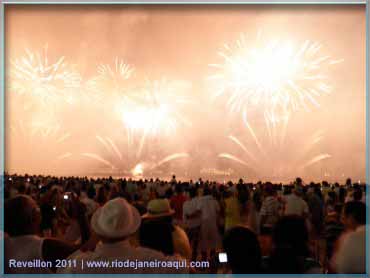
<box><xmin>1</xmin><ymin>174</ymin><xmax>367</xmax><ymax>274</ymax></box>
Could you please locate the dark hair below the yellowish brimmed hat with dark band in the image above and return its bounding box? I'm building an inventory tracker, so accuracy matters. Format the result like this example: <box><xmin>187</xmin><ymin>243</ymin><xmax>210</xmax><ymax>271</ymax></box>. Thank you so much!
<box><xmin>139</xmin><ymin>217</ymin><xmax>174</xmax><ymax>255</ymax></box>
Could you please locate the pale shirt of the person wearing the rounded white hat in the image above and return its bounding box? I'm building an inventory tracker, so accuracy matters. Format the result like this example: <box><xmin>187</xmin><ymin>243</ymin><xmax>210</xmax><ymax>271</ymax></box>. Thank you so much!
<box><xmin>58</xmin><ymin>240</ymin><xmax>189</xmax><ymax>274</ymax></box>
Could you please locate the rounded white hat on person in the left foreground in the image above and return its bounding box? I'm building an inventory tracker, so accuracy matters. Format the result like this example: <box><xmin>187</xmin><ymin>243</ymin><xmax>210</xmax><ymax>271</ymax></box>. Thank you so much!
<box><xmin>91</xmin><ymin>198</ymin><xmax>141</xmax><ymax>238</ymax></box>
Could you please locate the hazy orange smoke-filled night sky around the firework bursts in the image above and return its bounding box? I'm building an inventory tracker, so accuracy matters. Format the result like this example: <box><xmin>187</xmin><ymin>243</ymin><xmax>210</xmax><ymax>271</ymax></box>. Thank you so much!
<box><xmin>5</xmin><ymin>5</ymin><xmax>366</xmax><ymax>180</ymax></box>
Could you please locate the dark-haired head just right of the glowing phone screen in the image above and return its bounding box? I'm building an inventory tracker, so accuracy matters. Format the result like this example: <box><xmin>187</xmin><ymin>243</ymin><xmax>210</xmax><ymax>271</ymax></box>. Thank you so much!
<box><xmin>223</xmin><ymin>226</ymin><xmax>262</xmax><ymax>274</ymax></box>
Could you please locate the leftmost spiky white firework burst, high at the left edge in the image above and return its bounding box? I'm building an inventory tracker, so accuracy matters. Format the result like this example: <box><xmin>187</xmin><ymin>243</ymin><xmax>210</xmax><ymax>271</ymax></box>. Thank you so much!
<box><xmin>9</xmin><ymin>45</ymin><xmax>81</xmax><ymax>105</ymax></box>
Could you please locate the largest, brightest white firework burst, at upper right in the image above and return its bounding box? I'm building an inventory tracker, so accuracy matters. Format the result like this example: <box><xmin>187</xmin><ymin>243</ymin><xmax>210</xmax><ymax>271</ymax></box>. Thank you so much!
<box><xmin>210</xmin><ymin>32</ymin><xmax>342</xmax><ymax>122</ymax></box>
